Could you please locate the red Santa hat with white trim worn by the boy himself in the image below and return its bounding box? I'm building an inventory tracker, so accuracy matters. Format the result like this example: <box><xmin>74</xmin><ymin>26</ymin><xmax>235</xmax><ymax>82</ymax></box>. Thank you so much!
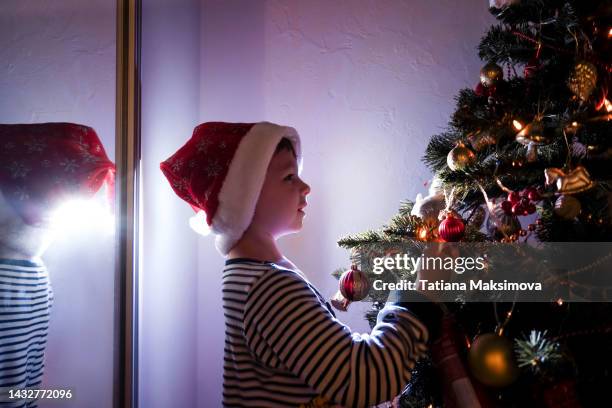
<box><xmin>160</xmin><ymin>122</ymin><xmax>301</xmax><ymax>255</ymax></box>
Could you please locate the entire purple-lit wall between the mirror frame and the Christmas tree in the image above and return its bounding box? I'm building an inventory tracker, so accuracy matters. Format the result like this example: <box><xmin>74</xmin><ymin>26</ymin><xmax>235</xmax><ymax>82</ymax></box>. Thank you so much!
<box><xmin>140</xmin><ymin>0</ymin><xmax>494</xmax><ymax>407</ymax></box>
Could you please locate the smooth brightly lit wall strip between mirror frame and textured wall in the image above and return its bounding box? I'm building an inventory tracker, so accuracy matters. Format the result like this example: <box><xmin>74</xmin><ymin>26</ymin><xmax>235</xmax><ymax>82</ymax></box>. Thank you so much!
<box><xmin>138</xmin><ymin>0</ymin><xmax>200</xmax><ymax>408</ymax></box>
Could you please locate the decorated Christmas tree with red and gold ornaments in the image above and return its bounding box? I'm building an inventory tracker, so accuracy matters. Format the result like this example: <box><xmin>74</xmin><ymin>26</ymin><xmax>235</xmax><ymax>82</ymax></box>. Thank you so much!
<box><xmin>332</xmin><ymin>0</ymin><xmax>612</xmax><ymax>407</ymax></box>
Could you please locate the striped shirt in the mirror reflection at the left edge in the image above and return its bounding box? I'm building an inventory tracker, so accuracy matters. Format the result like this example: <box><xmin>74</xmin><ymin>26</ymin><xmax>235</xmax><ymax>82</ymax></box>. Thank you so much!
<box><xmin>0</xmin><ymin>259</ymin><xmax>53</xmax><ymax>407</ymax></box>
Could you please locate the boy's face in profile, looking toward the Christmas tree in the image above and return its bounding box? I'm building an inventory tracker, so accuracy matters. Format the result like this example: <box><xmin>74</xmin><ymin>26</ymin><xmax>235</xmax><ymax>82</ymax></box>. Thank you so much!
<box><xmin>251</xmin><ymin>150</ymin><xmax>310</xmax><ymax>238</ymax></box>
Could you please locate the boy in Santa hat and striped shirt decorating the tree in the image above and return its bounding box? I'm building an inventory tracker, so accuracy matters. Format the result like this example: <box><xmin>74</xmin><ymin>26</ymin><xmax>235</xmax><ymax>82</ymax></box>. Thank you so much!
<box><xmin>161</xmin><ymin>122</ymin><xmax>439</xmax><ymax>408</ymax></box>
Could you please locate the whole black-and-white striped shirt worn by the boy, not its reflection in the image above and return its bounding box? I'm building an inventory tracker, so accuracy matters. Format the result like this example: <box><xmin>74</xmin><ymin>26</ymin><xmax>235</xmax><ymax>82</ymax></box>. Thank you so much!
<box><xmin>223</xmin><ymin>258</ymin><xmax>428</xmax><ymax>408</ymax></box>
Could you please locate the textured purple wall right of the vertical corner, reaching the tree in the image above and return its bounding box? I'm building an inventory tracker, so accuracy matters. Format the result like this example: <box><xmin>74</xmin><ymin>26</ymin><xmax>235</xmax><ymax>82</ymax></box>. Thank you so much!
<box><xmin>198</xmin><ymin>0</ymin><xmax>493</xmax><ymax>406</ymax></box>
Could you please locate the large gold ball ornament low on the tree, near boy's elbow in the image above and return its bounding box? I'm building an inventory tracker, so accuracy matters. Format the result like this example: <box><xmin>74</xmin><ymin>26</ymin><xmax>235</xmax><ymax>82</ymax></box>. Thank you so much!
<box><xmin>468</xmin><ymin>333</ymin><xmax>519</xmax><ymax>388</ymax></box>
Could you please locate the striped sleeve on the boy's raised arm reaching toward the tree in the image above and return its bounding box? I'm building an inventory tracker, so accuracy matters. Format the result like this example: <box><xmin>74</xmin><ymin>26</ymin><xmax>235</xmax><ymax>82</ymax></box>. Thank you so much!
<box><xmin>244</xmin><ymin>269</ymin><xmax>428</xmax><ymax>407</ymax></box>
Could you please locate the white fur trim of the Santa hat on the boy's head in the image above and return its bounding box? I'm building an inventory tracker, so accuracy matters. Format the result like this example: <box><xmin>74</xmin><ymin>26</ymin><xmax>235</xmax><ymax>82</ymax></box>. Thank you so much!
<box><xmin>211</xmin><ymin>122</ymin><xmax>302</xmax><ymax>256</ymax></box>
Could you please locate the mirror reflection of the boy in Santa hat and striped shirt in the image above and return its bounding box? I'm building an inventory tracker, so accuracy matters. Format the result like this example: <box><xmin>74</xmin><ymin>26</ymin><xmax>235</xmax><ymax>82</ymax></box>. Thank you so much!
<box><xmin>0</xmin><ymin>123</ymin><xmax>115</xmax><ymax>407</ymax></box>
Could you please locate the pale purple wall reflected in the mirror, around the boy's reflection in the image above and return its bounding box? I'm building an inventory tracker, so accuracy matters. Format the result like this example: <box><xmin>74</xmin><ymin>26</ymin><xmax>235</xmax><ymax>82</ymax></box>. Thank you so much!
<box><xmin>0</xmin><ymin>0</ymin><xmax>116</xmax><ymax>408</ymax></box>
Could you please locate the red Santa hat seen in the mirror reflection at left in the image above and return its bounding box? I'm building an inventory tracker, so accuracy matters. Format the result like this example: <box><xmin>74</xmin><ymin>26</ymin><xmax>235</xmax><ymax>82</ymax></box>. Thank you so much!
<box><xmin>0</xmin><ymin>123</ymin><xmax>115</xmax><ymax>225</ymax></box>
